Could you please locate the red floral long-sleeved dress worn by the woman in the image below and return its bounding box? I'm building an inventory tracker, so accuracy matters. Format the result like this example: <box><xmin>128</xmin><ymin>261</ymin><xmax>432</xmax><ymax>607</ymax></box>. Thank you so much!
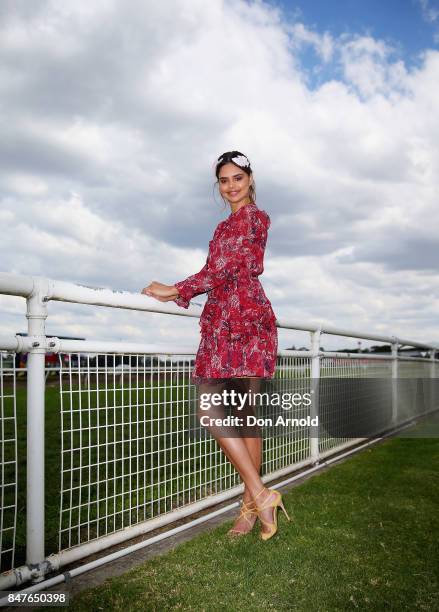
<box><xmin>174</xmin><ymin>202</ymin><xmax>278</xmax><ymax>384</ymax></box>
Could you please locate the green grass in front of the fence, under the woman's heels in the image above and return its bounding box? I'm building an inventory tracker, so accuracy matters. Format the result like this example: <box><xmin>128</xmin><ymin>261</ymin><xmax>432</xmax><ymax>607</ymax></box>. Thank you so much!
<box><xmin>46</xmin><ymin>438</ymin><xmax>439</xmax><ymax>612</ymax></box>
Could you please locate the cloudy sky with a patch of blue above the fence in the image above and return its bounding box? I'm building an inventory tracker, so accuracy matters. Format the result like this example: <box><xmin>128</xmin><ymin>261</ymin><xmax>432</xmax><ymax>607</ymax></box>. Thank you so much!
<box><xmin>0</xmin><ymin>0</ymin><xmax>439</xmax><ymax>348</ymax></box>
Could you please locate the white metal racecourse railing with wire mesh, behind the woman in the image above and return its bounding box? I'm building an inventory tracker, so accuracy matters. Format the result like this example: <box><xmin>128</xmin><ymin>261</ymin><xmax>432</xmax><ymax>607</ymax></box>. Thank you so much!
<box><xmin>0</xmin><ymin>273</ymin><xmax>439</xmax><ymax>590</ymax></box>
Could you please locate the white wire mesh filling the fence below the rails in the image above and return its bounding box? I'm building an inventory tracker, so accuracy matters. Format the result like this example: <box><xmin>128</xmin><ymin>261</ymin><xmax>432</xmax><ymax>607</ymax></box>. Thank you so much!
<box><xmin>0</xmin><ymin>344</ymin><xmax>437</xmax><ymax>571</ymax></box>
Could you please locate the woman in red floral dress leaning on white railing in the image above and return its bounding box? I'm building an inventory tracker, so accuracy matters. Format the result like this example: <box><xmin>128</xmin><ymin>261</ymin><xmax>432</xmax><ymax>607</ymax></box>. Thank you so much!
<box><xmin>142</xmin><ymin>151</ymin><xmax>289</xmax><ymax>540</ymax></box>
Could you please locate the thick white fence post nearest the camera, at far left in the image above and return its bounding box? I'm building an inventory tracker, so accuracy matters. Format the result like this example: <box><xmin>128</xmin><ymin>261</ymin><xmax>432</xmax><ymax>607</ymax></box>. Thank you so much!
<box><xmin>26</xmin><ymin>280</ymin><xmax>47</xmax><ymax>582</ymax></box>
